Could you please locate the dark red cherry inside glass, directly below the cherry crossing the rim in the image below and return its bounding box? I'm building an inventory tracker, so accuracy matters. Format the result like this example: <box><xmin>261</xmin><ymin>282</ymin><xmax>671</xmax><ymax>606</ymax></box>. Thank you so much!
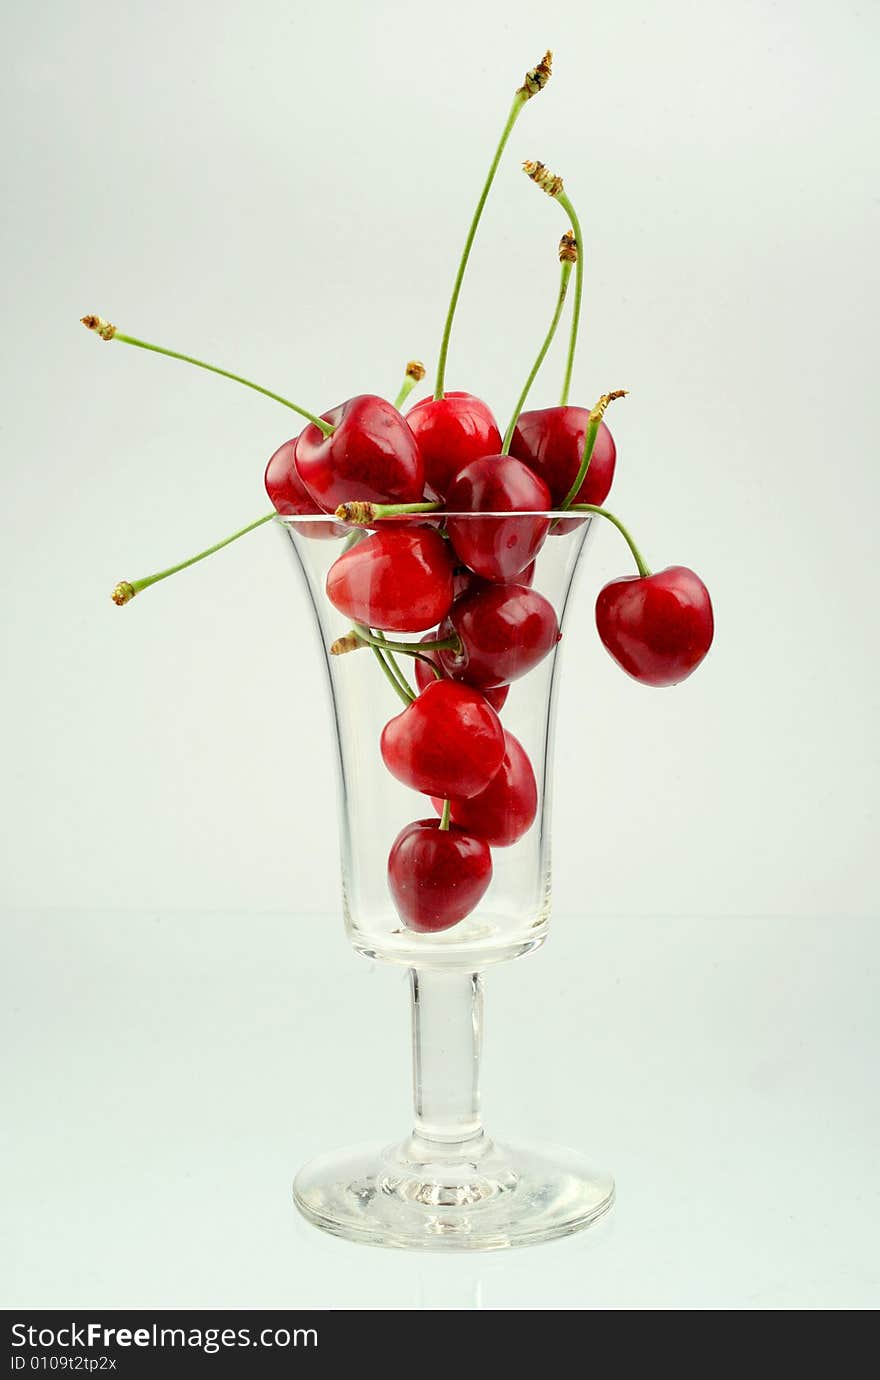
<box><xmin>437</xmin><ymin>585</ymin><xmax>561</xmax><ymax>690</ymax></box>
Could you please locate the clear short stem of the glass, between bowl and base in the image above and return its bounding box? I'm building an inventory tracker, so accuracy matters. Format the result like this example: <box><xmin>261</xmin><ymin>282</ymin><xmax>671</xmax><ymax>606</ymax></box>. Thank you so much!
<box><xmin>410</xmin><ymin>967</ymin><xmax>483</xmax><ymax>1154</ymax></box>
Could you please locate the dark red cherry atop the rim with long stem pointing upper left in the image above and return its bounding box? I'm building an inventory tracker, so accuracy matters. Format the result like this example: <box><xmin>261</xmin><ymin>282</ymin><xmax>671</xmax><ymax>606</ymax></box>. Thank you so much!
<box><xmin>297</xmin><ymin>393</ymin><xmax>425</xmax><ymax>512</ymax></box>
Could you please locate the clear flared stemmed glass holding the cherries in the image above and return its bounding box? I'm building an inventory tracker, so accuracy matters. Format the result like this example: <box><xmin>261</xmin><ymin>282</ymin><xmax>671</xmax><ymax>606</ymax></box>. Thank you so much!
<box><xmin>286</xmin><ymin>513</ymin><xmax>614</xmax><ymax>1249</ymax></box>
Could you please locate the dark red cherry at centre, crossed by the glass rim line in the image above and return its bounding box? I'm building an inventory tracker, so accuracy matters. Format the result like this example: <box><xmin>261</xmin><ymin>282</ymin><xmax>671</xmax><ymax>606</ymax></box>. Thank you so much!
<box><xmin>446</xmin><ymin>455</ymin><xmax>552</xmax><ymax>580</ymax></box>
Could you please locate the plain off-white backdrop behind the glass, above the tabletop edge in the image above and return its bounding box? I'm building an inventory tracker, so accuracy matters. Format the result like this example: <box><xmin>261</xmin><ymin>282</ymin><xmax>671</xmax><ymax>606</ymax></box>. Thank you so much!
<box><xmin>0</xmin><ymin>0</ymin><xmax>880</xmax><ymax>1308</ymax></box>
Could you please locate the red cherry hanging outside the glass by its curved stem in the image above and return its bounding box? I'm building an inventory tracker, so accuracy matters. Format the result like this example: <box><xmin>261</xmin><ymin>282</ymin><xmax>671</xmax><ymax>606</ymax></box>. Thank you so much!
<box><xmin>596</xmin><ymin>566</ymin><xmax>714</xmax><ymax>686</ymax></box>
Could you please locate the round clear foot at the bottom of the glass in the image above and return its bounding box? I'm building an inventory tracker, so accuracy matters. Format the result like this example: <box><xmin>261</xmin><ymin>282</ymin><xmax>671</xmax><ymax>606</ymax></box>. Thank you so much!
<box><xmin>294</xmin><ymin>1134</ymin><xmax>614</xmax><ymax>1250</ymax></box>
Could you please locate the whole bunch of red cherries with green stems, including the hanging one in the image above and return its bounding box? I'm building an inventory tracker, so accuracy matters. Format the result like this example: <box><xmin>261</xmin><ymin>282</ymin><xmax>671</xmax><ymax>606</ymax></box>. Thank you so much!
<box><xmin>83</xmin><ymin>54</ymin><xmax>713</xmax><ymax>933</ymax></box>
